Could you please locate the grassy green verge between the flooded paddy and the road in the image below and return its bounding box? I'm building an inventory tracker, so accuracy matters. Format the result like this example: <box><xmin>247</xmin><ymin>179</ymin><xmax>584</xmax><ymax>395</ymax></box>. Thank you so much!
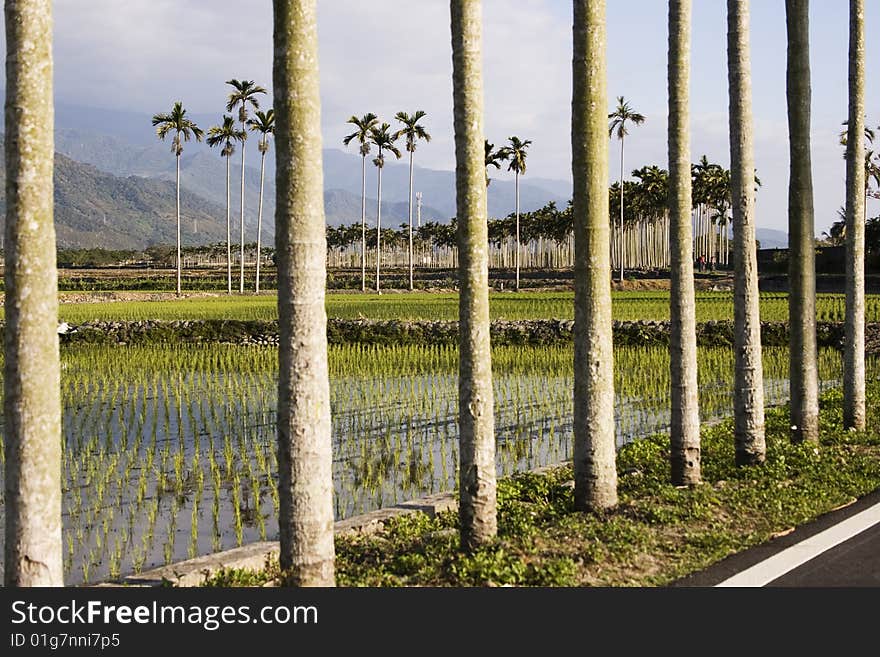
<box><xmin>199</xmin><ymin>382</ymin><xmax>880</xmax><ymax>586</ymax></box>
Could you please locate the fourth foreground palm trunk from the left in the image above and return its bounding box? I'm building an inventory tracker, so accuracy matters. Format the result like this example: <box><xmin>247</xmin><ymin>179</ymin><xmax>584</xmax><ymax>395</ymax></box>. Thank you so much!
<box><xmin>571</xmin><ymin>0</ymin><xmax>617</xmax><ymax>511</ymax></box>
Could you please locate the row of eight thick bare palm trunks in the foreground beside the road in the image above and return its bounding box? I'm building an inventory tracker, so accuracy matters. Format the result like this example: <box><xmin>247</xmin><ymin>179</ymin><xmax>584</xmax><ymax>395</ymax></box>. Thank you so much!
<box><xmin>4</xmin><ymin>0</ymin><xmax>865</xmax><ymax>586</ymax></box>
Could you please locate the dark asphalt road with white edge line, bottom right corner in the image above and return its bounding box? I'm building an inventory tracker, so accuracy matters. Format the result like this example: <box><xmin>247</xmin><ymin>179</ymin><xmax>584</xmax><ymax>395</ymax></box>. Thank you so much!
<box><xmin>672</xmin><ymin>491</ymin><xmax>880</xmax><ymax>587</ymax></box>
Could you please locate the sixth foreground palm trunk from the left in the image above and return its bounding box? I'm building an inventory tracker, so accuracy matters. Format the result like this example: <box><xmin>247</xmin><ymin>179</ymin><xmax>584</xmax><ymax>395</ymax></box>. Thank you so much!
<box><xmin>727</xmin><ymin>0</ymin><xmax>766</xmax><ymax>465</ymax></box>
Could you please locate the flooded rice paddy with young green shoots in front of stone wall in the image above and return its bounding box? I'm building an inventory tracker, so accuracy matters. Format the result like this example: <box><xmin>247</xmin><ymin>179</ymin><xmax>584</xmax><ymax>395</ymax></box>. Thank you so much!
<box><xmin>0</xmin><ymin>338</ymin><xmax>880</xmax><ymax>584</ymax></box>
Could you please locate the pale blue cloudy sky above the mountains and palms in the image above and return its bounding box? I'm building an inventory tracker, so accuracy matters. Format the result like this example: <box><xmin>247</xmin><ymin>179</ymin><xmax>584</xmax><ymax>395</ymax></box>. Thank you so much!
<box><xmin>5</xmin><ymin>0</ymin><xmax>880</xmax><ymax>235</ymax></box>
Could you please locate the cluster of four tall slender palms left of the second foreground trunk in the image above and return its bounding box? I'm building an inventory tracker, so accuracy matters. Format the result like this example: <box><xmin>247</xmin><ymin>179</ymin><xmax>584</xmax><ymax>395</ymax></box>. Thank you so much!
<box><xmin>152</xmin><ymin>78</ymin><xmax>275</xmax><ymax>296</ymax></box>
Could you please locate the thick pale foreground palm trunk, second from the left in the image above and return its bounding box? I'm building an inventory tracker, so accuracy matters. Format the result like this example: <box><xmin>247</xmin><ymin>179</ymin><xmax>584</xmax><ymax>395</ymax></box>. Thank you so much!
<box><xmin>272</xmin><ymin>0</ymin><xmax>335</xmax><ymax>586</ymax></box>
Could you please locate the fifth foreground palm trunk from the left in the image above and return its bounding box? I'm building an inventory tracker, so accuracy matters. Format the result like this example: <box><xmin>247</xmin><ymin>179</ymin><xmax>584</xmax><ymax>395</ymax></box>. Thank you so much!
<box><xmin>668</xmin><ymin>0</ymin><xmax>701</xmax><ymax>486</ymax></box>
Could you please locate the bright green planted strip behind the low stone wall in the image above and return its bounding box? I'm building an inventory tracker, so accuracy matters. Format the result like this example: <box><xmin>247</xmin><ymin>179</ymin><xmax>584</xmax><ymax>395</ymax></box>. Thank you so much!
<box><xmin>37</xmin><ymin>292</ymin><xmax>880</xmax><ymax>324</ymax></box>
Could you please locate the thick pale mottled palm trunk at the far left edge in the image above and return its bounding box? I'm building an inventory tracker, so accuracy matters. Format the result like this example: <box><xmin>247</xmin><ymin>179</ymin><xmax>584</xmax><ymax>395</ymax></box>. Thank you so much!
<box><xmin>3</xmin><ymin>0</ymin><xmax>64</xmax><ymax>587</ymax></box>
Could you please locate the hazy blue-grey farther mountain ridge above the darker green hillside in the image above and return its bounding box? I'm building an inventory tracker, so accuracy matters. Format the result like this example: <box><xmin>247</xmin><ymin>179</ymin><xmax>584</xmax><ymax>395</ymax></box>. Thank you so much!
<box><xmin>48</xmin><ymin>103</ymin><xmax>571</xmax><ymax>222</ymax></box>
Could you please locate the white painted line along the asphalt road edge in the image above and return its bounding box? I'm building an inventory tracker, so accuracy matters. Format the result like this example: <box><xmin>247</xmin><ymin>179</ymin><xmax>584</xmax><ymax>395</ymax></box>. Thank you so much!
<box><xmin>715</xmin><ymin>504</ymin><xmax>880</xmax><ymax>587</ymax></box>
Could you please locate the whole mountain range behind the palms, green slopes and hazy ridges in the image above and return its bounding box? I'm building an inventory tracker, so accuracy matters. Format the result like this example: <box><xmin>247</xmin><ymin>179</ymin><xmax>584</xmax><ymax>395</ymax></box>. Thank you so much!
<box><xmin>0</xmin><ymin>103</ymin><xmax>787</xmax><ymax>249</ymax></box>
